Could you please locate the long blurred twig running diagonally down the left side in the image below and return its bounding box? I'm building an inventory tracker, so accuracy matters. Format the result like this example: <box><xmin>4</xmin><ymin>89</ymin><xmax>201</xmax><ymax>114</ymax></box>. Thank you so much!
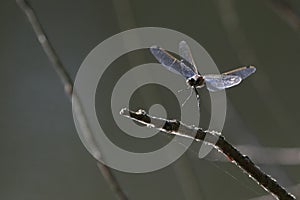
<box><xmin>16</xmin><ymin>0</ymin><xmax>128</xmax><ymax>200</ymax></box>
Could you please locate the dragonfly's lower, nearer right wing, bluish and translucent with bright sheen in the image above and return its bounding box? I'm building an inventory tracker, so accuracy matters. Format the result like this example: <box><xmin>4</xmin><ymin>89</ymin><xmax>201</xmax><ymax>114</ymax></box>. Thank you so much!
<box><xmin>203</xmin><ymin>74</ymin><xmax>242</xmax><ymax>92</ymax></box>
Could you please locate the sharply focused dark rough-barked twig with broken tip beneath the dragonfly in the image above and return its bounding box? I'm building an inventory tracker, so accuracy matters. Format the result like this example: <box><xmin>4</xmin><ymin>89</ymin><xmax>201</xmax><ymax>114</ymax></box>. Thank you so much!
<box><xmin>120</xmin><ymin>108</ymin><xmax>295</xmax><ymax>200</ymax></box>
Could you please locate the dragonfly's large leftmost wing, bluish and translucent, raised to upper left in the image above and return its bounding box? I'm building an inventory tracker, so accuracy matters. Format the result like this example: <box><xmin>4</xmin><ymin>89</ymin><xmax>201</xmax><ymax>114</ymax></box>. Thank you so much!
<box><xmin>150</xmin><ymin>46</ymin><xmax>195</xmax><ymax>79</ymax></box>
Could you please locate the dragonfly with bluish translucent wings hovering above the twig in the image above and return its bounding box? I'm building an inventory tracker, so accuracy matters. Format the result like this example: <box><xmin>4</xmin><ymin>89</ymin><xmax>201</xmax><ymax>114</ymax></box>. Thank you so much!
<box><xmin>150</xmin><ymin>41</ymin><xmax>256</xmax><ymax>108</ymax></box>
